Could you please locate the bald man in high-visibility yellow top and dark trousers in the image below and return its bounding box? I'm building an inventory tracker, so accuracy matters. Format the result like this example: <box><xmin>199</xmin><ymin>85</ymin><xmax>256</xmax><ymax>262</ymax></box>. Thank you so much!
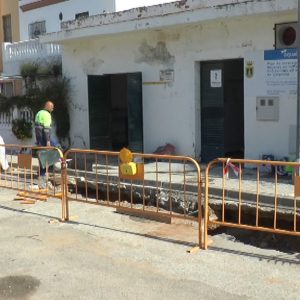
<box><xmin>34</xmin><ymin>101</ymin><xmax>54</xmax><ymax>176</ymax></box>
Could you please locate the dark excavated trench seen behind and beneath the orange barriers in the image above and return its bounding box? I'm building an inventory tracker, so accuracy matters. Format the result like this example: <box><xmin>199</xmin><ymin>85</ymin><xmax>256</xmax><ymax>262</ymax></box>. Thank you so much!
<box><xmin>71</xmin><ymin>180</ymin><xmax>300</xmax><ymax>253</ymax></box>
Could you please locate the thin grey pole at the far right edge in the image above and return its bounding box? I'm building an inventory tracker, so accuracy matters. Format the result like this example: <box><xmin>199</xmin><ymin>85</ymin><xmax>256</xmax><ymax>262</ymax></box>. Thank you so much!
<box><xmin>296</xmin><ymin>1</ymin><xmax>300</xmax><ymax>164</ymax></box>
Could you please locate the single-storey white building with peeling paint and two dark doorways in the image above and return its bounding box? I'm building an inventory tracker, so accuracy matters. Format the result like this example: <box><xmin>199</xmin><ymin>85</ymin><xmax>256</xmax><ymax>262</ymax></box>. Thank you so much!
<box><xmin>41</xmin><ymin>0</ymin><xmax>298</xmax><ymax>161</ymax></box>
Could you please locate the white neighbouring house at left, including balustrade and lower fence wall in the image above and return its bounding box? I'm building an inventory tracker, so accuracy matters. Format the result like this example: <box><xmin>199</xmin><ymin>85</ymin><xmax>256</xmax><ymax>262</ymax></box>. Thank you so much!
<box><xmin>0</xmin><ymin>0</ymin><xmax>115</xmax><ymax>144</ymax></box>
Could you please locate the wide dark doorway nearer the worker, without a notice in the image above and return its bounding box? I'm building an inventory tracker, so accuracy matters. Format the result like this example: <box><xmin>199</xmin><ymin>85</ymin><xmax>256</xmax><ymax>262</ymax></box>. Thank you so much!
<box><xmin>88</xmin><ymin>73</ymin><xmax>143</xmax><ymax>152</ymax></box>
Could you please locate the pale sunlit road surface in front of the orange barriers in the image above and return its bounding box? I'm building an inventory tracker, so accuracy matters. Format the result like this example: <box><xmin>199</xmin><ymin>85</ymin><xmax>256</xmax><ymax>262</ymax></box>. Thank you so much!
<box><xmin>0</xmin><ymin>189</ymin><xmax>300</xmax><ymax>300</ymax></box>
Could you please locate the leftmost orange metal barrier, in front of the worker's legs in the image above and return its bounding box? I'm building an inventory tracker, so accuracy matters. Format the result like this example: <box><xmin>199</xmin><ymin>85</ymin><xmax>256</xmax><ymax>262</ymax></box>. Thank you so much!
<box><xmin>0</xmin><ymin>144</ymin><xmax>64</xmax><ymax>212</ymax></box>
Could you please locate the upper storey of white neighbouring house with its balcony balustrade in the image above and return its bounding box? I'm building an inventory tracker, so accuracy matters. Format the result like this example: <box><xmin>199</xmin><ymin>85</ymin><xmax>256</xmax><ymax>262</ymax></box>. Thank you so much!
<box><xmin>3</xmin><ymin>0</ymin><xmax>115</xmax><ymax>76</ymax></box>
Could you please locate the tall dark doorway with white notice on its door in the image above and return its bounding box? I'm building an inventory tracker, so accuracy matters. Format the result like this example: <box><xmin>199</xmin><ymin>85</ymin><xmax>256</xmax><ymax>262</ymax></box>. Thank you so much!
<box><xmin>201</xmin><ymin>59</ymin><xmax>244</xmax><ymax>162</ymax></box>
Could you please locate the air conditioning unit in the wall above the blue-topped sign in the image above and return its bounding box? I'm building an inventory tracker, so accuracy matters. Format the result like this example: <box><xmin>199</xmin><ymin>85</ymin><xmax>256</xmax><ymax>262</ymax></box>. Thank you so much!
<box><xmin>275</xmin><ymin>22</ymin><xmax>298</xmax><ymax>49</ymax></box>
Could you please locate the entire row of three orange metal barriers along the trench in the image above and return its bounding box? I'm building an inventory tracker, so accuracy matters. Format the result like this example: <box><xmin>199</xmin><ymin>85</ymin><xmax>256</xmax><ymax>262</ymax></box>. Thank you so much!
<box><xmin>0</xmin><ymin>145</ymin><xmax>300</xmax><ymax>249</ymax></box>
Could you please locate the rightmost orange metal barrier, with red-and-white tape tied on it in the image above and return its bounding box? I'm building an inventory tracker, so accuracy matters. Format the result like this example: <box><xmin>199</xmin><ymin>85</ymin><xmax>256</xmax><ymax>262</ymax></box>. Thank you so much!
<box><xmin>204</xmin><ymin>158</ymin><xmax>300</xmax><ymax>249</ymax></box>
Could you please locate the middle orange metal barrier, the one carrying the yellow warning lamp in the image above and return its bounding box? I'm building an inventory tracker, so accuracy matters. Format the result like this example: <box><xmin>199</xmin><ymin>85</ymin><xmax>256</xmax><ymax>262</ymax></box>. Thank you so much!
<box><xmin>63</xmin><ymin>149</ymin><xmax>202</xmax><ymax>247</ymax></box>
